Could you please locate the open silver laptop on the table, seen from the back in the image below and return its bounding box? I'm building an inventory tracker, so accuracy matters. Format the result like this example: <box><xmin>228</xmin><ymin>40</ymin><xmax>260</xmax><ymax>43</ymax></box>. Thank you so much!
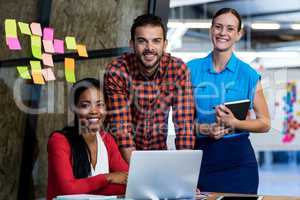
<box><xmin>125</xmin><ymin>150</ymin><xmax>202</xmax><ymax>199</ymax></box>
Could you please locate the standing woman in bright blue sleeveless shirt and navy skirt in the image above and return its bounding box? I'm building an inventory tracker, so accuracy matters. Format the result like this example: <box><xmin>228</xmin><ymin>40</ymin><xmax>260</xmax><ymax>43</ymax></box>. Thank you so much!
<box><xmin>188</xmin><ymin>8</ymin><xmax>270</xmax><ymax>194</ymax></box>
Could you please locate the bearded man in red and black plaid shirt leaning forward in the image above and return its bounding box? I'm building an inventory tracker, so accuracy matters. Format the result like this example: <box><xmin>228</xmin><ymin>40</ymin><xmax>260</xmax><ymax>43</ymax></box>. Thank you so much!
<box><xmin>104</xmin><ymin>14</ymin><xmax>195</xmax><ymax>162</ymax></box>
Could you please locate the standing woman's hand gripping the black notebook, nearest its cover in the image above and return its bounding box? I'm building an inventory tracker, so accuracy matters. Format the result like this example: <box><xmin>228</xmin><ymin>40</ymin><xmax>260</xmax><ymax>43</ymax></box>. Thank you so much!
<box><xmin>216</xmin><ymin>105</ymin><xmax>239</xmax><ymax>129</ymax></box>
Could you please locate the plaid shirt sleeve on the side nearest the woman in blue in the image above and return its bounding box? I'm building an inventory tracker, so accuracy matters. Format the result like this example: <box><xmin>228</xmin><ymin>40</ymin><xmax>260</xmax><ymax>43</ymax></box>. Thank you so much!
<box><xmin>172</xmin><ymin>60</ymin><xmax>195</xmax><ymax>149</ymax></box>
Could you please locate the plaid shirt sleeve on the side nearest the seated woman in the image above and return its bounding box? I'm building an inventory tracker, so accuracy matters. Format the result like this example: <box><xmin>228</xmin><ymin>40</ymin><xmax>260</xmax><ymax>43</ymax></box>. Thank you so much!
<box><xmin>104</xmin><ymin>62</ymin><xmax>135</xmax><ymax>148</ymax></box>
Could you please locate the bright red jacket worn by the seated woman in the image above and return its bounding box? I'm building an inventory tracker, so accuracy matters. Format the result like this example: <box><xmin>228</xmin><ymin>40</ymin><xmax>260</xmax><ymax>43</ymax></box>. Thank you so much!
<box><xmin>47</xmin><ymin>131</ymin><xmax>128</xmax><ymax>200</ymax></box>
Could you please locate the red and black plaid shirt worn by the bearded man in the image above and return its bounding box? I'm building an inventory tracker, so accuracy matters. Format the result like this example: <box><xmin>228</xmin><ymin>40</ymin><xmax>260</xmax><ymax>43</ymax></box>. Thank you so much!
<box><xmin>104</xmin><ymin>53</ymin><xmax>195</xmax><ymax>150</ymax></box>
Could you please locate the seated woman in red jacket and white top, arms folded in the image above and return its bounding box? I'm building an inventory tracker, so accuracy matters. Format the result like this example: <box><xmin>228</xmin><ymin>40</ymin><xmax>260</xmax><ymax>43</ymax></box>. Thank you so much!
<box><xmin>47</xmin><ymin>78</ymin><xmax>128</xmax><ymax>200</ymax></box>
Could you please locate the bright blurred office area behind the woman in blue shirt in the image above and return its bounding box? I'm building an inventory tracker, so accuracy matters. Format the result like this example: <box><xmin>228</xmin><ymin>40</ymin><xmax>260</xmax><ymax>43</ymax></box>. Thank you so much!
<box><xmin>168</xmin><ymin>0</ymin><xmax>300</xmax><ymax>195</ymax></box>
